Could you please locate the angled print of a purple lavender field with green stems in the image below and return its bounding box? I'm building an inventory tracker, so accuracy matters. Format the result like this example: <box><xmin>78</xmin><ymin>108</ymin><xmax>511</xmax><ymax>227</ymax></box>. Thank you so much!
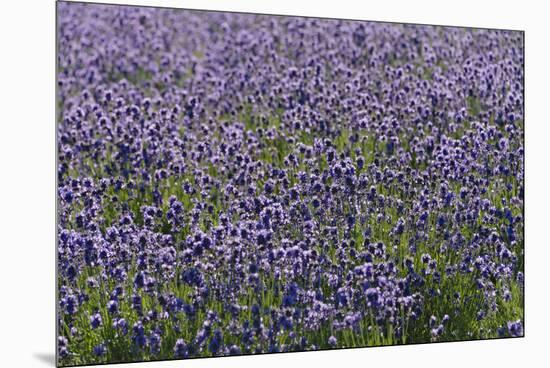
<box><xmin>56</xmin><ymin>3</ymin><xmax>524</xmax><ymax>366</ymax></box>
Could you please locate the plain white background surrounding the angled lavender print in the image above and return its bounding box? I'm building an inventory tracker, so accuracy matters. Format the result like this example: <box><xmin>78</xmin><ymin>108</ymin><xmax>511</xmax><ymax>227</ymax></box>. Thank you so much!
<box><xmin>0</xmin><ymin>0</ymin><xmax>550</xmax><ymax>368</ymax></box>
